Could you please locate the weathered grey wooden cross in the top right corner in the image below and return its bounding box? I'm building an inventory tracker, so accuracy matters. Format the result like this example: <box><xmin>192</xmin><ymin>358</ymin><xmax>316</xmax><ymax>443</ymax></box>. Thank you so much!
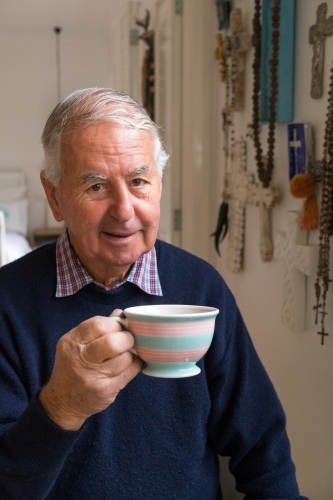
<box><xmin>309</xmin><ymin>2</ymin><xmax>333</xmax><ymax>99</ymax></box>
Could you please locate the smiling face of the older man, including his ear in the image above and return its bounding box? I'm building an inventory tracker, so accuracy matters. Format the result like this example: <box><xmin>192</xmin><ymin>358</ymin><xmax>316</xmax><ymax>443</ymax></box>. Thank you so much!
<box><xmin>42</xmin><ymin>122</ymin><xmax>162</xmax><ymax>286</ymax></box>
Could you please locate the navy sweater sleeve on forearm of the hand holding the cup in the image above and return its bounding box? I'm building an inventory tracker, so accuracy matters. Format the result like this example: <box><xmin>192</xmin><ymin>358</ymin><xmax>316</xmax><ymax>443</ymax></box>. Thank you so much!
<box><xmin>0</xmin><ymin>395</ymin><xmax>84</xmax><ymax>500</ymax></box>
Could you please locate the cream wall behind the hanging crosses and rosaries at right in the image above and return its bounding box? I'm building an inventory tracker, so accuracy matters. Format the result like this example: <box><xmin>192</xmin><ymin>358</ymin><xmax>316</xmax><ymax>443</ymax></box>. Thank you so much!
<box><xmin>206</xmin><ymin>0</ymin><xmax>333</xmax><ymax>500</ymax></box>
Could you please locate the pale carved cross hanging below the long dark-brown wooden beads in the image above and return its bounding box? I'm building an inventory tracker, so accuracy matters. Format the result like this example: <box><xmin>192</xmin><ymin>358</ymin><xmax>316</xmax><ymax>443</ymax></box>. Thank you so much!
<box><xmin>247</xmin><ymin>162</ymin><xmax>280</xmax><ymax>262</ymax></box>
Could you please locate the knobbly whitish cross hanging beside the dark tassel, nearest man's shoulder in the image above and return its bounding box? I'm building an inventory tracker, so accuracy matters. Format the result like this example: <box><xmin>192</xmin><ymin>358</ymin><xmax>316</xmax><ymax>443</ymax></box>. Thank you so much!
<box><xmin>224</xmin><ymin>139</ymin><xmax>253</xmax><ymax>273</ymax></box>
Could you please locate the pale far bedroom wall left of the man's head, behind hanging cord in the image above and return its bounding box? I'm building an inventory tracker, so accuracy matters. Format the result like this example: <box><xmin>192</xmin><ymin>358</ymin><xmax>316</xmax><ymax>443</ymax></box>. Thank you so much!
<box><xmin>0</xmin><ymin>33</ymin><xmax>110</xmax><ymax>232</ymax></box>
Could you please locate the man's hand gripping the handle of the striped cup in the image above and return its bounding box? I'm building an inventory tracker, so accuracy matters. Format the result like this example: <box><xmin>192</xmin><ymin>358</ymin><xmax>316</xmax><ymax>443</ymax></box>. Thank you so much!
<box><xmin>39</xmin><ymin>309</ymin><xmax>142</xmax><ymax>430</ymax></box>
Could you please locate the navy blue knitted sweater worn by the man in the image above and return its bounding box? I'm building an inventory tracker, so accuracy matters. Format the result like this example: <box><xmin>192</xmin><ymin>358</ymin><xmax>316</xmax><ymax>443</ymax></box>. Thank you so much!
<box><xmin>0</xmin><ymin>241</ymin><xmax>306</xmax><ymax>500</ymax></box>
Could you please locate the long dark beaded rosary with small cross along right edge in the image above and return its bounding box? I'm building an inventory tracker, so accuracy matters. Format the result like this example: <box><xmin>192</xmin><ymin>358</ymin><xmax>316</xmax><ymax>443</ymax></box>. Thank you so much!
<box><xmin>314</xmin><ymin>63</ymin><xmax>333</xmax><ymax>345</ymax></box>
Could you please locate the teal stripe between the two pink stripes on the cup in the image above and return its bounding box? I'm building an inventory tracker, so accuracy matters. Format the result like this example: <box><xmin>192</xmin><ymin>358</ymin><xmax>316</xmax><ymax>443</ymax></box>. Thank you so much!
<box><xmin>134</xmin><ymin>332</ymin><xmax>213</xmax><ymax>351</ymax></box>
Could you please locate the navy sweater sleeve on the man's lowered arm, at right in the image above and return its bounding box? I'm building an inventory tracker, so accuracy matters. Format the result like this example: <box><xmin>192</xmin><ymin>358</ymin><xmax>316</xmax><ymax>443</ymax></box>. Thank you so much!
<box><xmin>206</xmin><ymin>292</ymin><xmax>304</xmax><ymax>500</ymax></box>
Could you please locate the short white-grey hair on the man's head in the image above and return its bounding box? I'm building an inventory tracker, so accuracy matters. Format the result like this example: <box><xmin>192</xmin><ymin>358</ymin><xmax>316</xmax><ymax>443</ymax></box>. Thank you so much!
<box><xmin>42</xmin><ymin>88</ymin><xmax>169</xmax><ymax>186</ymax></box>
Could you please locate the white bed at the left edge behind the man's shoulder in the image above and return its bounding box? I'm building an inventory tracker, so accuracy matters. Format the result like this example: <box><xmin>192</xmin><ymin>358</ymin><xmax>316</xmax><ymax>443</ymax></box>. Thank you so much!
<box><xmin>0</xmin><ymin>169</ymin><xmax>32</xmax><ymax>266</ymax></box>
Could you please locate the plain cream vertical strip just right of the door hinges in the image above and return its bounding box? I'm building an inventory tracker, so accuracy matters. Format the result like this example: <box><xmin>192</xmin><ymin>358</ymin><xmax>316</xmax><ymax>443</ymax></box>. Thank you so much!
<box><xmin>179</xmin><ymin>0</ymin><xmax>216</xmax><ymax>260</ymax></box>
